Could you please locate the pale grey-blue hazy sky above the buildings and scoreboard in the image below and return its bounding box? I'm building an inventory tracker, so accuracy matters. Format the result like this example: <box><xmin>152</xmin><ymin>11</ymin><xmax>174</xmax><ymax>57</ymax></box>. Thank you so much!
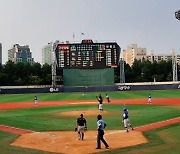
<box><xmin>0</xmin><ymin>0</ymin><xmax>180</xmax><ymax>64</ymax></box>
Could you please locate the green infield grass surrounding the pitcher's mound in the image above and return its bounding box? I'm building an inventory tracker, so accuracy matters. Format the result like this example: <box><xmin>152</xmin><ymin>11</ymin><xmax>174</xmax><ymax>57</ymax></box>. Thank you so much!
<box><xmin>0</xmin><ymin>104</ymin><xmax>180</xmax><ymax>131</ymax></box>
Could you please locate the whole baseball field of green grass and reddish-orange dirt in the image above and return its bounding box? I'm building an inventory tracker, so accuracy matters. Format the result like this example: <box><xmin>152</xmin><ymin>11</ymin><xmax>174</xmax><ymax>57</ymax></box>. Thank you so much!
<box><xmin>0</xmin><ymin>90</ymin><xmax>180</xmax><ymax>154</ymax></box>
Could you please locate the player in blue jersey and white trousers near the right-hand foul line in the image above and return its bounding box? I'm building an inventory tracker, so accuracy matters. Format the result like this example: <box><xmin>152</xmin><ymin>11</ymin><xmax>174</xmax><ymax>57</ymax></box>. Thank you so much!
<box><xmin>122</xmin><ymin>108</ymin><xmax>134</xmax><ymax>132</ymax></box>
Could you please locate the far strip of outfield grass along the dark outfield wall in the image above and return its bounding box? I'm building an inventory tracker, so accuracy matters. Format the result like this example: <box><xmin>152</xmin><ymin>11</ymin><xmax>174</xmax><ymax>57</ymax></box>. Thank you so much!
<box><xmin>0</xmin><ymin>90</ymin><xmax>180</xmax><ymax>103</ymax></box>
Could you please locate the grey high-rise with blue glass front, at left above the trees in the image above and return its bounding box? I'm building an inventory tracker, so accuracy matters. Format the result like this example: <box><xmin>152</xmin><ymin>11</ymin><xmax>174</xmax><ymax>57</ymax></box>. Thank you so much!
<box><xmin>8</xmin><ymin>44</ymin><xmax>34</xmax><ymax>64</ymax></box>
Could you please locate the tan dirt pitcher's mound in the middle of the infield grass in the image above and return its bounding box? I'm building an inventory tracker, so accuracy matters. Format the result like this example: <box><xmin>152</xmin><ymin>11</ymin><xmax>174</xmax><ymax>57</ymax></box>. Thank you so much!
<box><xmin>58</xmin><ymin>110</ymin><xmax>108</xmax><ymax>116</ymax></box>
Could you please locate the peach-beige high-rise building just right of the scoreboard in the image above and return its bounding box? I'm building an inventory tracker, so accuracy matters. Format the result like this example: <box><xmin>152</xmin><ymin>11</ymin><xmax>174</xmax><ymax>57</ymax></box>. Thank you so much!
<box><xmin>123</xmin><ymin>44</ymin><xmax>146</xmax><ymax>66</ymax></box>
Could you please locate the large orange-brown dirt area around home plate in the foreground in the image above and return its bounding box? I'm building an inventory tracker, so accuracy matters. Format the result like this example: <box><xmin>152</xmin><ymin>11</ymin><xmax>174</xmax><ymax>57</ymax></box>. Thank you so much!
<box><xmin>11</xmin><ymin>130</ymin><xmax>147</xmax><ymax>154</ymax></box>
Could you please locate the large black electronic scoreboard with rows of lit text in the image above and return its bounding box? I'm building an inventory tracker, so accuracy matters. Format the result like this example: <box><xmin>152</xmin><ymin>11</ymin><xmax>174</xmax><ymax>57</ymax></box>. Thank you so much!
<box><xmin>56</xmin><ymin>40</ymin><xmax>120</xmax><ymax>69</ymax></box>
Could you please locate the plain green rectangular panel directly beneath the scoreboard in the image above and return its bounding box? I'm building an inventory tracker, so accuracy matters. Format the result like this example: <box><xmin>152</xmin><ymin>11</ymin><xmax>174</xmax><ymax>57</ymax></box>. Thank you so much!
<box><xmin>63</xmin><ymin>68</ymin><xmax>114</xmax><ymax>86</ymax></box>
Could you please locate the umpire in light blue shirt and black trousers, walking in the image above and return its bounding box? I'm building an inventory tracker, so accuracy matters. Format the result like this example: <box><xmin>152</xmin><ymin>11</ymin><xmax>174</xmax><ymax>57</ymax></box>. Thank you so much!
<box><xmin>96</xmin><ymin>115</ymin><xmax>109</xmax><ymax>149</ymax></box>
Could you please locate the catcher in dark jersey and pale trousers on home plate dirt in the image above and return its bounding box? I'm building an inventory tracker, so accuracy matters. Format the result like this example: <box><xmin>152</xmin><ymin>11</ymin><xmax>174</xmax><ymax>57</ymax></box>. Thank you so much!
<box><xmin>75</xmin><ymin>114</ymin><xmax>87</xmax><ymax>140</ymax></box>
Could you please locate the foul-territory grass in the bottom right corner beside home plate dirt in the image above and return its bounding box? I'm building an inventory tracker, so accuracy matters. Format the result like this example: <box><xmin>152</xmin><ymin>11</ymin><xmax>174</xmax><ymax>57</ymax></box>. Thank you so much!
<box><xmin>102</xmin><ymin>124</ymin><xmax>180</xmax><ymax>154</ymax></box>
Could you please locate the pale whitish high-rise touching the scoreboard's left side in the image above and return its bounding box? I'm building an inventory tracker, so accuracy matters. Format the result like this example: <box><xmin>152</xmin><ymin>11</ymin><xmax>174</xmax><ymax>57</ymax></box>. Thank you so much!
<box><xmin>42</xmin><ymin>42</ymin><xmax>53</xmax><ymax>65</ymax></box>
